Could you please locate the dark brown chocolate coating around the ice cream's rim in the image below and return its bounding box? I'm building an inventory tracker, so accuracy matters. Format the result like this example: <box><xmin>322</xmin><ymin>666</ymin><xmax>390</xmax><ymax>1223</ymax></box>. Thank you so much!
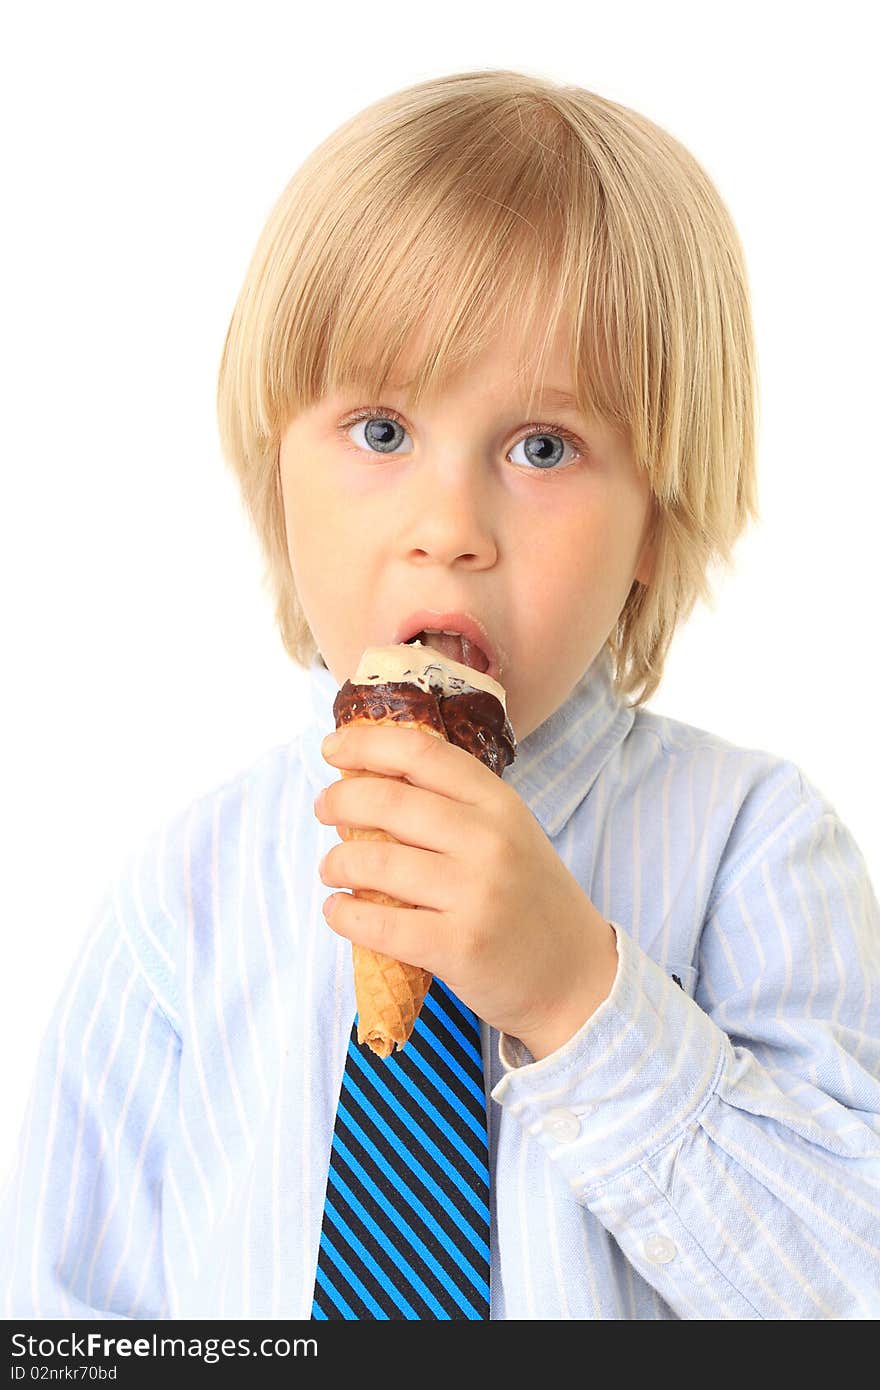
<box><xmin>334</xmin><ymin>681</ymin><xmax>516</xmax><ymax>777</ymax></box>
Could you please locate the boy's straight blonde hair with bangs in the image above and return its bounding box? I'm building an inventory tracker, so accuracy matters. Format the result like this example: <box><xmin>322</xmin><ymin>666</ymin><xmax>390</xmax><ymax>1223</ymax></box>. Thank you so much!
<box><xmin>217</xmin><ymin>70</ymin><xmax>759</xmax><ymax>705</ymax></box>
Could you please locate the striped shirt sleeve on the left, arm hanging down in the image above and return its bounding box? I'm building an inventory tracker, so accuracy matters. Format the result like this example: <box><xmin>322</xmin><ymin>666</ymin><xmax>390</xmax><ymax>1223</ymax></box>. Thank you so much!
<box><xmin>0</xmin><ymin>861</ymin><xmax>179</xmax><ymax>1319</ymax></box>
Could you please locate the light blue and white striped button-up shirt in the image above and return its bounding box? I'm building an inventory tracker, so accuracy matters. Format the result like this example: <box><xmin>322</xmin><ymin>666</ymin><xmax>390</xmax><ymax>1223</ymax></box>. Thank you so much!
<box><xmin>0</xmin><ymin>652</ymin><xmax>880</xmax><ymax>1319</ymax></box>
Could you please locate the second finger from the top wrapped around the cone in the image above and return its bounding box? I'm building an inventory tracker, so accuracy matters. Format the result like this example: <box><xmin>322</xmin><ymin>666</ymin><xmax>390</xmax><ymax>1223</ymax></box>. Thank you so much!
<box><xmin>314</xmin><ymin>770</ymin><xmax>485</xmax><ymax>855</ymax></box>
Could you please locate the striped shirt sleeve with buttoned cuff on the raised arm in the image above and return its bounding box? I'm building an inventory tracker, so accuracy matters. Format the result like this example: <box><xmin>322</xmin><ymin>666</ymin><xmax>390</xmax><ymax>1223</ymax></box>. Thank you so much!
<box><xmin>492</xmin><ymin>760</ymin><xmax>880</xmax><ymax>1319</ymax></box>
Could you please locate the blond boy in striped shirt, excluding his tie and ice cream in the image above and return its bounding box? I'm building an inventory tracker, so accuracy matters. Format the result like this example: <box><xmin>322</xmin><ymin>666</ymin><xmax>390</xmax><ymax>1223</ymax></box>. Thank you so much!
<box><xmin>0</xmin><ymin>71</ymin><xmax>880</xmax><ymax>1319</ymax></box>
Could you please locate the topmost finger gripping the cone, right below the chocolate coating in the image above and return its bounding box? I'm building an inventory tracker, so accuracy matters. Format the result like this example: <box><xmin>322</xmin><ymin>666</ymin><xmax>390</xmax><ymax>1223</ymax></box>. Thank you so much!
<box><xmin>321</xmin><ymin>724</ymin><xmax>503</xmax><ymax>806</ymax></box>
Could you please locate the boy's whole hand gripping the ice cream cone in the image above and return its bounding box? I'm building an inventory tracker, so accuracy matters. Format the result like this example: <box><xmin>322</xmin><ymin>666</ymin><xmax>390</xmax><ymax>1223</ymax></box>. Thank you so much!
<box><xmin>314</xmin><ymin>724</ymin><xmax>617</xmax><ymax>1061</ymax></box>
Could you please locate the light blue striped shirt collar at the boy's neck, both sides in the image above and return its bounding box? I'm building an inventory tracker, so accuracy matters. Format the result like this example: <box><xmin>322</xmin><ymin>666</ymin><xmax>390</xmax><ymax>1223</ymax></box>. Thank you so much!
<box><xmin>303</xmin><ymin>646</ymin><xmax>635</xmax><ymax>838</ymax></box>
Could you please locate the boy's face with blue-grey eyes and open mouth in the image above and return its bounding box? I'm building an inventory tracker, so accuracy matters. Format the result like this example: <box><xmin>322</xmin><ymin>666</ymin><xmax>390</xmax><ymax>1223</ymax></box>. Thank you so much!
<box><xmin>281</xmin><ymin>318</ymin><xmax>652</xmax><ymax>739</ymax></box>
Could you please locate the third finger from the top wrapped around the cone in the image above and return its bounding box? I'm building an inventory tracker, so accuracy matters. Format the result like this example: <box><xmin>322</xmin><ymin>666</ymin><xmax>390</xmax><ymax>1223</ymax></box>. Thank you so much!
<box><xmin>318</xmin><ymin>840</ymin><xmax>456</xmax><ymax>912</ymax></box>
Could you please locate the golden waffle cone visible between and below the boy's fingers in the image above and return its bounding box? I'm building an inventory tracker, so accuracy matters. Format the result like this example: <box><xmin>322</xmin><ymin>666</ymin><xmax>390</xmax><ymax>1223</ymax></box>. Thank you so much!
<box><xmin>338</xmin><ymin>719</ymin><xmax>443</xmax><ymax>1056</ymax></box>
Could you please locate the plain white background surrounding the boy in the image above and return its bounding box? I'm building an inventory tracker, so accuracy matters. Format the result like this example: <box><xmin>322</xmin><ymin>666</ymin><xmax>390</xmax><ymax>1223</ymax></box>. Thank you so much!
<box><xmin>0</xmin><ymin>0</ymin><xmax>880</xmax><ymax>1175</ymax></box>
